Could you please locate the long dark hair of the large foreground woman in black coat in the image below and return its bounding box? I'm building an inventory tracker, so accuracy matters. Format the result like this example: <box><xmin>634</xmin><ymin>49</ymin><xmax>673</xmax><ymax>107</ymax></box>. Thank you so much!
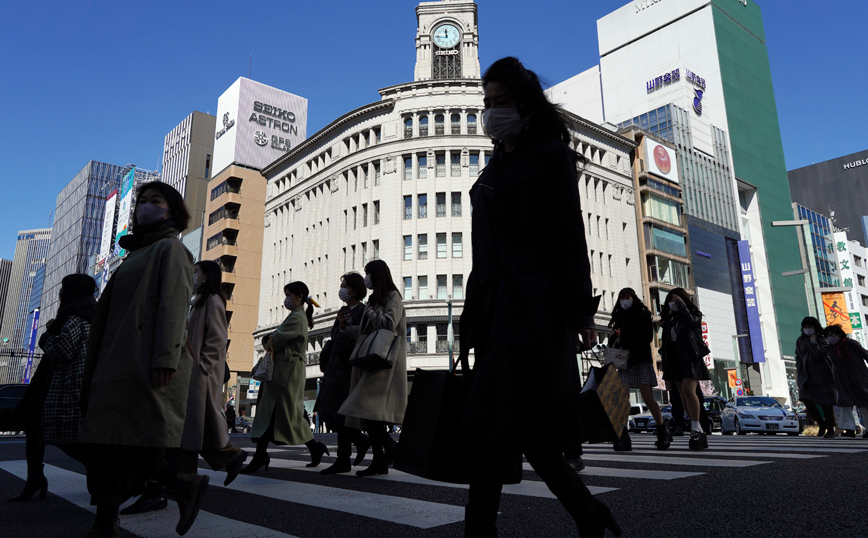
<box><xmin>482</xmin><ymin>56</ymin><xmax>570</xmax><ymax>148</ymax></box>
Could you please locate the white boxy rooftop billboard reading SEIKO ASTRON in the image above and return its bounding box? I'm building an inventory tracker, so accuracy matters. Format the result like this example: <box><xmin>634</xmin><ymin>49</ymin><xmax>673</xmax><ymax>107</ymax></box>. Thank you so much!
<box><xmin>214</xmin><ymin>77</ymin><xmax>307</xmax><ymax>173</ymax></box>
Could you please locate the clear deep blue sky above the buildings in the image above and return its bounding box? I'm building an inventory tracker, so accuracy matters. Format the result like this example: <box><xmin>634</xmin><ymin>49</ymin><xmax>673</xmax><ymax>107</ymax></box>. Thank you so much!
<box><xmin>0</xmin><ymin>0</ymin><xmax>868</xmax><ymax>259</ymax></box>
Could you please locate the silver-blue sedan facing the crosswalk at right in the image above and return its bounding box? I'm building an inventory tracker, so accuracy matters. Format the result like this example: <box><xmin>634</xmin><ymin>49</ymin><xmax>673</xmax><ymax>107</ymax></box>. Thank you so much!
<box><xmin>720</xmin><ymin>396</ymin><xmax>800</xmax><ymax>435</ymax></box>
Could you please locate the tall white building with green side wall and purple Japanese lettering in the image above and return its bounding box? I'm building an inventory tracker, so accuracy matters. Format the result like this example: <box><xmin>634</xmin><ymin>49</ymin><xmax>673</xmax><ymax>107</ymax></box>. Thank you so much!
<box><xmin>550</xmin><ymin>0</ymin><xmax>807</xmax><ymax>397</ymax></box>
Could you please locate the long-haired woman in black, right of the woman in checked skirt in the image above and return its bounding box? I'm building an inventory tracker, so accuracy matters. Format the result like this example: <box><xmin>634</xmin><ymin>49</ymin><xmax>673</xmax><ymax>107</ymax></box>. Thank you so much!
<box><xmin>660</xmin><ymin>288</ymin><xmax>711</xmax><ymax>450</ymax></box>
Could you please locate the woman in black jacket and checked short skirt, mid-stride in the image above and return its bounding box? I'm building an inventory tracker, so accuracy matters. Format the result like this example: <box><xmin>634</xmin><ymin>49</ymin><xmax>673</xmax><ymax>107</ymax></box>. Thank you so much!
<box><xmin>609</xmin><ymin>288</ymin><xmax>672</xmax><ymax>452</ymax></box>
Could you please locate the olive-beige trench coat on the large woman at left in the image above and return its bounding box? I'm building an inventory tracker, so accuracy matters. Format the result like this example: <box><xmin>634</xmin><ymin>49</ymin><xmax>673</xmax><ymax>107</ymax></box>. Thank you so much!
<box><xmin>80</xmin><ymin>229</ymin><xmax>193</xmax><ymax>448</ymax></box>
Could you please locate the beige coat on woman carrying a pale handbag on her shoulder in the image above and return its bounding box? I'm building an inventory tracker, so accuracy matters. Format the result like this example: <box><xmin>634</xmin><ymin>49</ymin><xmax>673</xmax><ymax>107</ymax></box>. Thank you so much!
<box><xmin>338</xmin><ymin>291</ymin><xmax>407</xmax><ymax>426</ymax></box>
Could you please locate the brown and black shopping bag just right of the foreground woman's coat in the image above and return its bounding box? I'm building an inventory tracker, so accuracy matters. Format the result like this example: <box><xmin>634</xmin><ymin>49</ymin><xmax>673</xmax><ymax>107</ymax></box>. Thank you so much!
<box><xmin>579</xmin><ymin>364</ymin><xmax>630</xmax><ymax>443</ymax></box>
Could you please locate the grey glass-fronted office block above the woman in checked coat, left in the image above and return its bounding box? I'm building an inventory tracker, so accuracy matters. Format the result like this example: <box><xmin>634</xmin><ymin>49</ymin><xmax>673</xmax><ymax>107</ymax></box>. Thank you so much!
<box><xmin>39</xmin><ymin>161</ymin><xmax>123</xmax><ymax>331</ymax></box>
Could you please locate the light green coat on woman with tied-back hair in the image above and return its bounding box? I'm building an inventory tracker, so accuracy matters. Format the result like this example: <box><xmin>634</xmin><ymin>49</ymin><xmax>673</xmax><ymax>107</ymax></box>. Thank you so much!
<box><xmin>250</xmin><ymin>306</ymin><xmax>313</xmax><ymax>445</ymax></box>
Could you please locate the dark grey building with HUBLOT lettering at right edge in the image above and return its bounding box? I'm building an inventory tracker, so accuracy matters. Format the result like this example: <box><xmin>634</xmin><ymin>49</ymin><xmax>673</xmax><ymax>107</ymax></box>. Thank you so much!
<box><xmin>787</xmin><ymin>150</ymin><xmax>868</xmax><ymax>246</ymax></box>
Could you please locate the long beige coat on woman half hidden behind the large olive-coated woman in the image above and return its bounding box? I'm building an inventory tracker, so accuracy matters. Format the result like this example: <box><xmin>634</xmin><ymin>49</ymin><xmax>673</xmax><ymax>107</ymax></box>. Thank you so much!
<box><xmin>181</xmin><ymin>295</ymin><xmax>229</xmax><ymax>452</ymax></box>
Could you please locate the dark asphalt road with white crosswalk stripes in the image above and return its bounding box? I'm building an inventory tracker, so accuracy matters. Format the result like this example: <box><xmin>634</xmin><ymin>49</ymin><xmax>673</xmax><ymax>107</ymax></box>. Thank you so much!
<box><xmin>0</xmin><ymin>434</ymin><xmax>868</xmax><ymax>538</ymax></box>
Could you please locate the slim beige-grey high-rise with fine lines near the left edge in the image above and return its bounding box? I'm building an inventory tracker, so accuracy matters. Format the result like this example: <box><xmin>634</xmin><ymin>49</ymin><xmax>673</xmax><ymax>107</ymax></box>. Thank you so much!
<box><xmin>0</xmin><ymin>228</ymin><xmax>51</xmax><ymax>352</ymax></box>
